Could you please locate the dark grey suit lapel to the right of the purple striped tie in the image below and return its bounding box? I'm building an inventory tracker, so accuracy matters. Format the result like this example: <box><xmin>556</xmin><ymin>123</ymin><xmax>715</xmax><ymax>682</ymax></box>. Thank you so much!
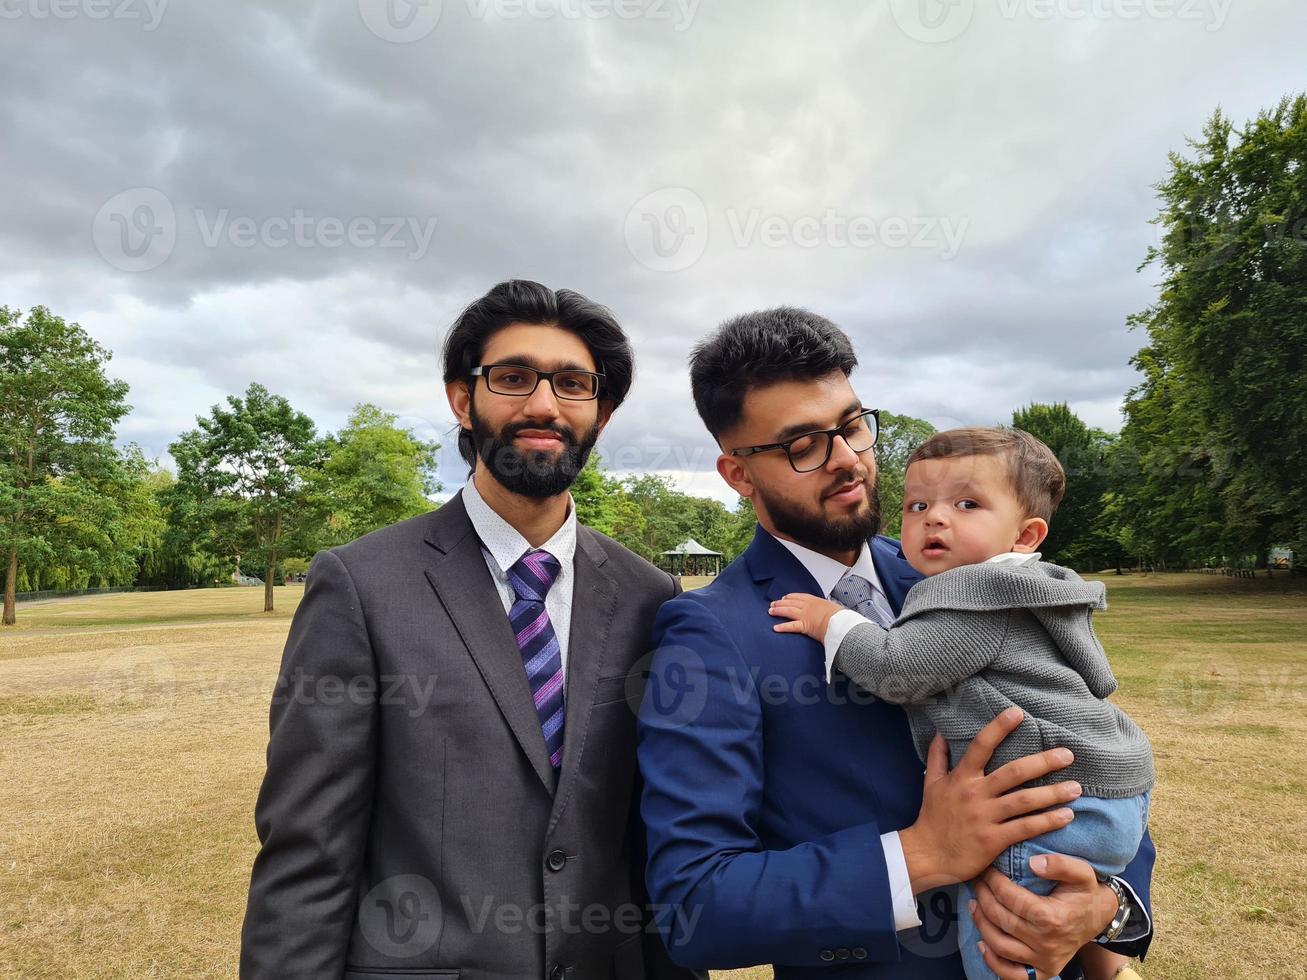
<box><xmin>541</xmin><ymin>525</ymin><xmax>617</xmax><ymax>827</ymax></box>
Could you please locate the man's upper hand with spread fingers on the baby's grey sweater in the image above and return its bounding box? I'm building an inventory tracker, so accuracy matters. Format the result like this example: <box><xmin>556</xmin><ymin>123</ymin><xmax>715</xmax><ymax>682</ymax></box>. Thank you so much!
<box><xmin>899</xmin><ymin>708</ymin><xmax>1082</xmax><ymax>898</ymax></box>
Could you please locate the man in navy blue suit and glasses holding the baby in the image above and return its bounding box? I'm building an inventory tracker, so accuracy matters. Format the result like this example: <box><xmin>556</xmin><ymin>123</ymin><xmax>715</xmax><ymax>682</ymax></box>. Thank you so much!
<box><xmin>639</xmin><ymin>308</ymin><xmax>1154</xmax><ymax>980</ymax></box>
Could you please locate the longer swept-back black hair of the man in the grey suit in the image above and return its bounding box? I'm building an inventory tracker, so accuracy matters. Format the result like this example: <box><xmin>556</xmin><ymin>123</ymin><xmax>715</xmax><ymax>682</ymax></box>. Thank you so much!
<box><xmin>443</xmin><ymin>280</ymin><xmax>635</xmax><ymax>466</ymax></box>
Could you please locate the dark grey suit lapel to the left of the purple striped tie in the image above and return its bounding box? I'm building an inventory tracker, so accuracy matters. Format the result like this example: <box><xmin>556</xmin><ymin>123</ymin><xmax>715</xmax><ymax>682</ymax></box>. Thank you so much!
<box><xmin>425</xmin><ymin>491</ymin><xmax>554</xmax><ymax>793</ymax></box>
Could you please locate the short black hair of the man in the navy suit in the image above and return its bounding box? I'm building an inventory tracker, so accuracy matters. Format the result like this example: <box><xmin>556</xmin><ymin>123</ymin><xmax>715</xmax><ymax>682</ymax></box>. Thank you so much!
<box><xmin>690</xmin><ymin>306</ymin><xmax>857</xmax><ymax>439</ymax></box>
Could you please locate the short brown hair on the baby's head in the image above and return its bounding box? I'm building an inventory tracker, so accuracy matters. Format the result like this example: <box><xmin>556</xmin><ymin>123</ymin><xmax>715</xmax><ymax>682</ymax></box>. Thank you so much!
<box><xmin>907</xmin><ymin>426</ymin><xmax>1067</xmax><ymax>521</ymax></box>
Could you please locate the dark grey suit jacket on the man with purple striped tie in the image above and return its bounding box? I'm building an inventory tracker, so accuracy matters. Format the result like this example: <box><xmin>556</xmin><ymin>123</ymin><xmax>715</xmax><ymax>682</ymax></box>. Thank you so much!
<box><xmin>240</xmin><ymin>495</ymin><xmax>691</xmax><ymax>980</ymax></box>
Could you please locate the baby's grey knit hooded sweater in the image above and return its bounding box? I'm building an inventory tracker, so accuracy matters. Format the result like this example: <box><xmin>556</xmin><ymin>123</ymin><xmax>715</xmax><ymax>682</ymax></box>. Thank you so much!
<box><xmin>835</xmin><ymin>562</ymin><xmax>1154</xmax><ymax>798</ymax></box>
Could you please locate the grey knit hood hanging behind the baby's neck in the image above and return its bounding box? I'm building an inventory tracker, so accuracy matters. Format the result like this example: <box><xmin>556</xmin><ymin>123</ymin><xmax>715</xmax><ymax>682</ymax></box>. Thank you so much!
<box><xmin>898</xmin><ymin>562</ymin><xmax>1116</xmax><ymax>698</ymax></box>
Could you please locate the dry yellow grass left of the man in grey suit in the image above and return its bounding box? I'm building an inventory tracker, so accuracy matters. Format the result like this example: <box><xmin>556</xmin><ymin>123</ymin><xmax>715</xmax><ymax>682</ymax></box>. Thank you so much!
<box><xmin>0</xmin><ymin>587</ymin><xmax>303</xmax><ymax>980</ymax></box>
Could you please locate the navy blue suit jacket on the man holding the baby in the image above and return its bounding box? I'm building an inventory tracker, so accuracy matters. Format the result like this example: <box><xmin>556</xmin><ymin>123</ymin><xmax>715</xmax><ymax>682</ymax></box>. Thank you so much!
<box><xmin>639</xmin><ymin>528</ymin><xmax>1153</xmax><ymax>980</ymax></box>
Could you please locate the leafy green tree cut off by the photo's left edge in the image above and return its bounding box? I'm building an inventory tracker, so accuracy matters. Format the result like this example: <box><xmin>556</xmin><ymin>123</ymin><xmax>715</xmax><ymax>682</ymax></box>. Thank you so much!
<box><xmin>0</xmin><ymin>306</ymin><xmax>129</xmax><ymax>626</ymax></box>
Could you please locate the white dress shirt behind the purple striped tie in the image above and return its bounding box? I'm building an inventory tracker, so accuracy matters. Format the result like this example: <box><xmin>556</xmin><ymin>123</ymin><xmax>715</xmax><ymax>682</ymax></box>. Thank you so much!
<box><xmin>463</xmin><ymin>477</ymin><xmax>576</xmax><ymax>699</ymax></box>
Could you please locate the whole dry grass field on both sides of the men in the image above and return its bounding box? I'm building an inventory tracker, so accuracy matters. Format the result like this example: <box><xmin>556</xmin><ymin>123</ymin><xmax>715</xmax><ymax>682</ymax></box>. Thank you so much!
<box><xmin>0</xmin><ymin>575</ymin><xmax>1307</xmax><ymax>980</ymax></box>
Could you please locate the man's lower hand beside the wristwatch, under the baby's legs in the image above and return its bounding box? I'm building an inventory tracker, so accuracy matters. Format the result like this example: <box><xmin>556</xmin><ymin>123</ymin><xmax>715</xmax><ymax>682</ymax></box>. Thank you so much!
<box><xmin>971</xmin><ymin>855</ymin><xmax>1116</xmax><ymax>980</ymax></box>
